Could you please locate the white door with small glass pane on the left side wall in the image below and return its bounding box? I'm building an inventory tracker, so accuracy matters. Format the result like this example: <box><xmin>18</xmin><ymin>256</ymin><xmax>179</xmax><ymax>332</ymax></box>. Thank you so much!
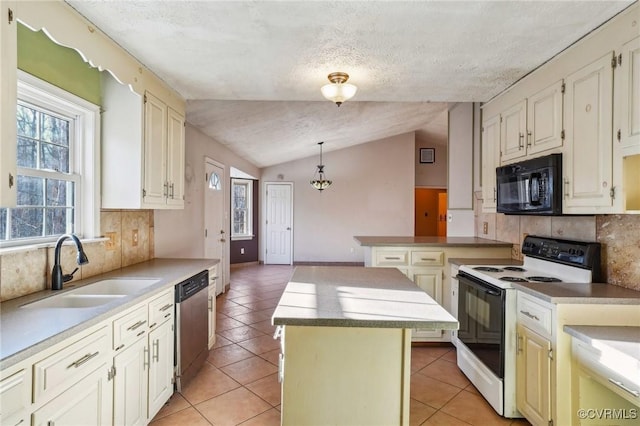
<box><xmin>204</xmin><ymin>159</ymin><xmax>227</xmax><ymax>295</ymax></box>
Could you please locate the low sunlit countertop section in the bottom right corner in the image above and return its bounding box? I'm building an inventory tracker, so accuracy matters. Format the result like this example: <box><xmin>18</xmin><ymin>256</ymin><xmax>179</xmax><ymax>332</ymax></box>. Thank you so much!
<box><xmin>563</xmin><ymin>325</ymin><xmax>640</xmax><ymax>362</ymax></box>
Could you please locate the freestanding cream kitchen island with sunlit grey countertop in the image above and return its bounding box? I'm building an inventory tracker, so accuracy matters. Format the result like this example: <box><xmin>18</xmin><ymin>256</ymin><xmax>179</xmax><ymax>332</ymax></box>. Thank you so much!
<box><xmin>272</xmin><ymin>266</ymin><xmax>458</xmax><ymax>426</ymax></box>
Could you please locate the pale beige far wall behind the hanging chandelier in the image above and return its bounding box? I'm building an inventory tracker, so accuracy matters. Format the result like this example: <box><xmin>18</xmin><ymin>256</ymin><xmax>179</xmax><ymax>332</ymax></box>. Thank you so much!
<box><xmin>260</xmin><ymin>132</ymin><xmax>415</xmax><ymax>262</ymax></box>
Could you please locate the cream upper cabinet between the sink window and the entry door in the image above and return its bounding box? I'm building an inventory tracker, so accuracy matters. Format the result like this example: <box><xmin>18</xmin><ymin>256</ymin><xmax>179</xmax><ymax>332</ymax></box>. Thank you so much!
<box><xmin>102</xmin><ymin>73</ymin><xmax>185</xmax><ymax>209</ymax></box>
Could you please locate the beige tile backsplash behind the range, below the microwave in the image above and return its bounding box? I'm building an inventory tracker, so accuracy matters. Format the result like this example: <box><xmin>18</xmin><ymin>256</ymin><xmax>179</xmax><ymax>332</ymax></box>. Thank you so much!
<box><xmin>475</xmin><ymin>194</ymin><xmax>640</xmax><ymax>291</ymax></box>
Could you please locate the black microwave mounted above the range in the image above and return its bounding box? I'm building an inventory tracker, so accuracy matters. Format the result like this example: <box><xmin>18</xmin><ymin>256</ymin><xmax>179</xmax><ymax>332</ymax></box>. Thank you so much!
<box><xmin>496</xmin><ymin>154</ymin><xmax>562</xmax><ymax>215</ymax></box>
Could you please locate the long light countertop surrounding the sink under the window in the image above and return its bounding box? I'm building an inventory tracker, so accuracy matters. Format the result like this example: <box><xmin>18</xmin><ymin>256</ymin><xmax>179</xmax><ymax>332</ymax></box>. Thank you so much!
<box><xmin>0</xmin><ymin>259</ymin><xmax>218</xmax><ymax>370</ymax></box>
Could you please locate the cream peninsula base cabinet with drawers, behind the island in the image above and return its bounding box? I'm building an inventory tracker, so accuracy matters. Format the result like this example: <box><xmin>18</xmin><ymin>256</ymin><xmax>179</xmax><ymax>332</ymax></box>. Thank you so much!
<box><xmin>365</xmin><ymin>244</ymin><xmax>511</xmax><ymax>342</ymax></box>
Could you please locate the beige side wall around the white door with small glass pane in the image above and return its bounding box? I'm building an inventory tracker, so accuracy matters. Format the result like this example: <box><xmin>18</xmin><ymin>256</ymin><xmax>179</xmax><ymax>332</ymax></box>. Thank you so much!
<box><xmin>154</xmin><ymin>124</ymin><xmax>260</xmax><ymax>284</ymax></box>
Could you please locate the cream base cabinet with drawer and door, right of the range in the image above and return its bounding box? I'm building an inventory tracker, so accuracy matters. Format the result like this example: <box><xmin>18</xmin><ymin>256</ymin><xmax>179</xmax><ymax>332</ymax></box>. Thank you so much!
<box><xmin>515</xmin><ymin>290</ymin><xmax>640</xmax><ymax>426</ymax></box>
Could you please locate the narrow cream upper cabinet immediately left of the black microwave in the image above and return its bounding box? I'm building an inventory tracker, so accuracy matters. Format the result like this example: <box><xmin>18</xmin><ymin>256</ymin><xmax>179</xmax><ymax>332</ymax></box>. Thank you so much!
<box><xmin>482</xmin><ymin>115</ymin><xmax>500</xmax><ymax>213</ymax></box>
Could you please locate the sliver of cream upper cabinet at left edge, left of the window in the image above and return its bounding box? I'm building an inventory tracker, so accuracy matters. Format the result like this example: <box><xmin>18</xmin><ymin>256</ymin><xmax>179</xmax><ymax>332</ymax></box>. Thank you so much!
<box><xmin>0</xmin><ymin>1</ymin><xmax>18</xmax><ymax>207</ymax></box>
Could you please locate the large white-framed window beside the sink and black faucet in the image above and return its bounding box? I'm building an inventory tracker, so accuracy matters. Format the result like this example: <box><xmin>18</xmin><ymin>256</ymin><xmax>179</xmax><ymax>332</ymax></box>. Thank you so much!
<box><xmin>0</xmin><ymin>72</ymin><xmax>100</xmax><ymax>246</ymax></box>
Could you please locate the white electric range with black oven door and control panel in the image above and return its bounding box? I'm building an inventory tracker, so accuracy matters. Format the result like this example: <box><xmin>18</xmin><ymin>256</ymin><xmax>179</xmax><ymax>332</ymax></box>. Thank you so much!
<box><xmin>457</xmin><ymin>236</ymin><xmax>600</xmax><ymax>417</ymax></box>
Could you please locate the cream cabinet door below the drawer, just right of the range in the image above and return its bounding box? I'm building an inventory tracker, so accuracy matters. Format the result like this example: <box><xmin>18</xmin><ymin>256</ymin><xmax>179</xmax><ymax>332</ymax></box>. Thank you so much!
<box><xmin>516</xmin><ymin>324</ymin><xmax>551</xmax><ymax>426</ymax></box>
